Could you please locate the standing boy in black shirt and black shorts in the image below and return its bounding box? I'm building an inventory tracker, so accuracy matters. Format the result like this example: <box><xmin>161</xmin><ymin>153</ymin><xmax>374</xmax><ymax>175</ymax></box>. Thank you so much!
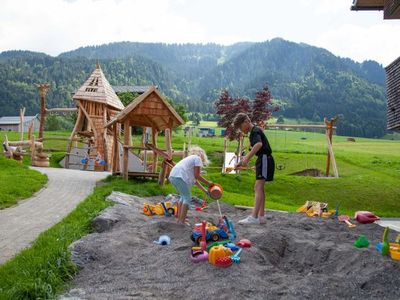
<box><xmin>233</xmin><ymin>113</ymin><xmax>275</xmax><ymax>224</ymax></box>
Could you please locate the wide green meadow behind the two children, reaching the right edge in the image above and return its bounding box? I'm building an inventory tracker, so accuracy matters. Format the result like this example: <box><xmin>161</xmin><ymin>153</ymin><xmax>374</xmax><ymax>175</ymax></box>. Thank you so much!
<box><xmin>0</xmin><ymin>129</ymin><xmax>400</xmax><ymax>217</ymax></box>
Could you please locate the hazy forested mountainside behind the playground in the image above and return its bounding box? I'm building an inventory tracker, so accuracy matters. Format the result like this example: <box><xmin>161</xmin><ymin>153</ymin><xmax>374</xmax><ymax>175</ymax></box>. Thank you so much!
<box><xmin>0</xmin><ymin>39</ymin><xmax>386</xmax><ymax>137</ymax></box>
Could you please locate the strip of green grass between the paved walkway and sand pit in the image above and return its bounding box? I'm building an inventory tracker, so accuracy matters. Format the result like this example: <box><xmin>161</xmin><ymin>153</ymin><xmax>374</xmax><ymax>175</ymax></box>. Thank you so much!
<box><xmin>0</xmin><ymin>177</ymin><xmax>172</xmax><ymax>299</ymax></box>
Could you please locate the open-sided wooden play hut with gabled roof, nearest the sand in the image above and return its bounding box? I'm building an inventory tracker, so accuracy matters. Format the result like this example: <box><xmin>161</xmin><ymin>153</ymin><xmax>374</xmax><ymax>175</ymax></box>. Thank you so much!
<box><xmin>106</xmin><ymin>86</ymin><xmax>186</xmax><ymax>184</ymax></box>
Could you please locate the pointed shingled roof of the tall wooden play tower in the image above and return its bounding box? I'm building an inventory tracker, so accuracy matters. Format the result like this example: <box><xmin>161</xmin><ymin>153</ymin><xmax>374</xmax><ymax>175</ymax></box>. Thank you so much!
<box><xmin>72</xmin><ymin>64</ymin><xmax>124</xmax><ymax>110</ymax></box>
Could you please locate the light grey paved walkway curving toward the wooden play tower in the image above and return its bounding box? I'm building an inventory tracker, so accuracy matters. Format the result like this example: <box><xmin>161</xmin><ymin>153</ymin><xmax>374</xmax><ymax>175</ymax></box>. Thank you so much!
<box><xmin>0</xmin><ymin>167</ymin><xmax>110</xmax><ymax>264</ymax></box>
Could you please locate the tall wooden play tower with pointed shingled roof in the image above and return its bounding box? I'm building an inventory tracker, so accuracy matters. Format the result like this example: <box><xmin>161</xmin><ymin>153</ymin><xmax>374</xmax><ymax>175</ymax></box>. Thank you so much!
<box><xmin>64</xmin><ymin>64</ymin><xmax>124</xmax><ymax>171</ymax></box>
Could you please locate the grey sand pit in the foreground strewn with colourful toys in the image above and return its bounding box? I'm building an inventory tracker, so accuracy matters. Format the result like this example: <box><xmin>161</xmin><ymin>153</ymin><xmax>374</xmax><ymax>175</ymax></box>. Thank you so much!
<box><xmin>64</xmin><ymin>193</ymin><xmax>400</xmax><ymax>299</ymax></box>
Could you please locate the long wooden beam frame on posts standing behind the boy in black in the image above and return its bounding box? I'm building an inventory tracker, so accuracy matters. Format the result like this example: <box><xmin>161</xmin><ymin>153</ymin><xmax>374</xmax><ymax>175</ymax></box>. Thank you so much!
<box><xmin>222</xmin><ymin>117</ymin><xmax>339</xmax><ymax>178</ymax></box>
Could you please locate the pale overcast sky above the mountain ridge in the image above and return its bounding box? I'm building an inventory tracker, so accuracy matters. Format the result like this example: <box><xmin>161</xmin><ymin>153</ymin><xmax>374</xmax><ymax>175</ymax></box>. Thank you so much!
<box><xmin>0</xmin><ymin>0</ymin><xmax>400</xmax><ymax>66</ymax></box>
